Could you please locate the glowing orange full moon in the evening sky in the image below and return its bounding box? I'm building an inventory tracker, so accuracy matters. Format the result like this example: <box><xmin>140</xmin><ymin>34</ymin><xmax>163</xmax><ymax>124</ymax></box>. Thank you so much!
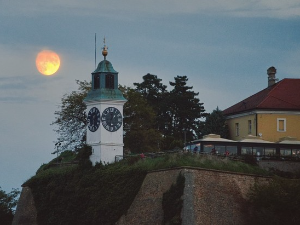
<box><xmin>35</xmin><ymin>50</ymin><xmax>60</xmax><ymax>76</ymax></box>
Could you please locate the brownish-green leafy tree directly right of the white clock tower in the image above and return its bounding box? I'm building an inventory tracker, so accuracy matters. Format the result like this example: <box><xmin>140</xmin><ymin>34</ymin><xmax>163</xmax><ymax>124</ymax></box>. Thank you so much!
<box><xmin>120</xmin><ymin>87</ymin><xmax>161</xmax><ymax>153</ymax></box>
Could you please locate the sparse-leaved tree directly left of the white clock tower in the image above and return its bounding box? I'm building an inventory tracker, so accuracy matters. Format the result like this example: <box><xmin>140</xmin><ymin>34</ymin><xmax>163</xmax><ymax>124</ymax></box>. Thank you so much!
<box><xmin>51</xmin><ymin>80</ymin><xmax>91</xmax><ymax>151</ymax></box>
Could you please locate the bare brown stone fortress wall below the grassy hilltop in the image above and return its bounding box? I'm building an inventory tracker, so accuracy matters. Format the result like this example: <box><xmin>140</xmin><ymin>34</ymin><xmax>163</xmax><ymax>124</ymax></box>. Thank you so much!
<box><xmin>13</xmin><ymin>167</ymin><xmax>271</xmax><ymax>225</ymax></box>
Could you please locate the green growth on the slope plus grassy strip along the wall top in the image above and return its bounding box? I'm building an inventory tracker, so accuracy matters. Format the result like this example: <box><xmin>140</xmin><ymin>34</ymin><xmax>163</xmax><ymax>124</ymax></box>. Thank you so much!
<box><xmin>24</xmin><ymin>147</ymin><xmax>300</xmax><ymax>225</ymax></box>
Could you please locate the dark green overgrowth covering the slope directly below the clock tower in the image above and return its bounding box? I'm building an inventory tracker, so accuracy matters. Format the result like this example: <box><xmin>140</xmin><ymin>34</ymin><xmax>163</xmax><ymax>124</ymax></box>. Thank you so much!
<box><xmin>24</xmin><ymin>163</ymin><xmax>146</xmax><ymax>225</ymax></box>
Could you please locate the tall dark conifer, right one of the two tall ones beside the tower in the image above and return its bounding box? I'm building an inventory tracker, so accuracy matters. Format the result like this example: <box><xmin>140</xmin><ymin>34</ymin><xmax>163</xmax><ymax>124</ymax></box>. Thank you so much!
<box><xmin>164</xmin><ymin>76</ymin><xmax>206</xmax><ymax>146</ymax></box>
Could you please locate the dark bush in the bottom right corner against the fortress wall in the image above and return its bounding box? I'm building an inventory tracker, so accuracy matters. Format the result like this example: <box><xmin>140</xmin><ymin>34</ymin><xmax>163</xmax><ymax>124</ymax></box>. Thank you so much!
<box><xmin>249</xmin><ymin>177</ymin><xmax>300</xmax><ymax>225</ymax></box>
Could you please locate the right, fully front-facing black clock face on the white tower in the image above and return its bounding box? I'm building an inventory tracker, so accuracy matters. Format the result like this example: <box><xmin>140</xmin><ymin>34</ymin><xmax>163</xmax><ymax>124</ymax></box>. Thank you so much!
<box><xmin>101</xmin><ymin>107</ymin><xmax>123</xmax><ymax>132</ymax></box>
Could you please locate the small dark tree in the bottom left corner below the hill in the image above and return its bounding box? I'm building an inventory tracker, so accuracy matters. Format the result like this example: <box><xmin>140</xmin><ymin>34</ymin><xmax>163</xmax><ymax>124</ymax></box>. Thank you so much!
<box><xmin>0</xmin><ymin>187</ymin><xmax>20</xmax><ymax>225</ymax></box>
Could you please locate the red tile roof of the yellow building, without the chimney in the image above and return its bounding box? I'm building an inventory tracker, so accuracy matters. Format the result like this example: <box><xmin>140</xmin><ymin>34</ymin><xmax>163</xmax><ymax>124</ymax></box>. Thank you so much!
<box><xmin>223</xmin><ymin>79</ymin><xmax>300</xmax><ymax>115</ymax></box>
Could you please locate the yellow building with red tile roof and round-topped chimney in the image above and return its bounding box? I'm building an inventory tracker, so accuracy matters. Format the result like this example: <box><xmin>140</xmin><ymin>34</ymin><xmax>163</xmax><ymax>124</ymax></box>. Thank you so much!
<box><xmin>223</xmin><ymin>67</ymin><xmax>300</xmax><ymax>142</ymax></box>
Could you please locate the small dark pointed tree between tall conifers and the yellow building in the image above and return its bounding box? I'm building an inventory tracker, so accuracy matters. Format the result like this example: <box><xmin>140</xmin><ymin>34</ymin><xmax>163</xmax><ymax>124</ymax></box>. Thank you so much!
<box><xmin>201</xmin><ymin>107</ymin><xmax>229</xmax><ymax>138</ymax></box>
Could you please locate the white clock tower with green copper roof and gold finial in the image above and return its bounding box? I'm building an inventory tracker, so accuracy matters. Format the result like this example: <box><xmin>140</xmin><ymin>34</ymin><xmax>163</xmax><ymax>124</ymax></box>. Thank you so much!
<box><xmin>84</xmin><ymin>43</ymin><xmax>126</xmax><ymax>165</ymax></box>
